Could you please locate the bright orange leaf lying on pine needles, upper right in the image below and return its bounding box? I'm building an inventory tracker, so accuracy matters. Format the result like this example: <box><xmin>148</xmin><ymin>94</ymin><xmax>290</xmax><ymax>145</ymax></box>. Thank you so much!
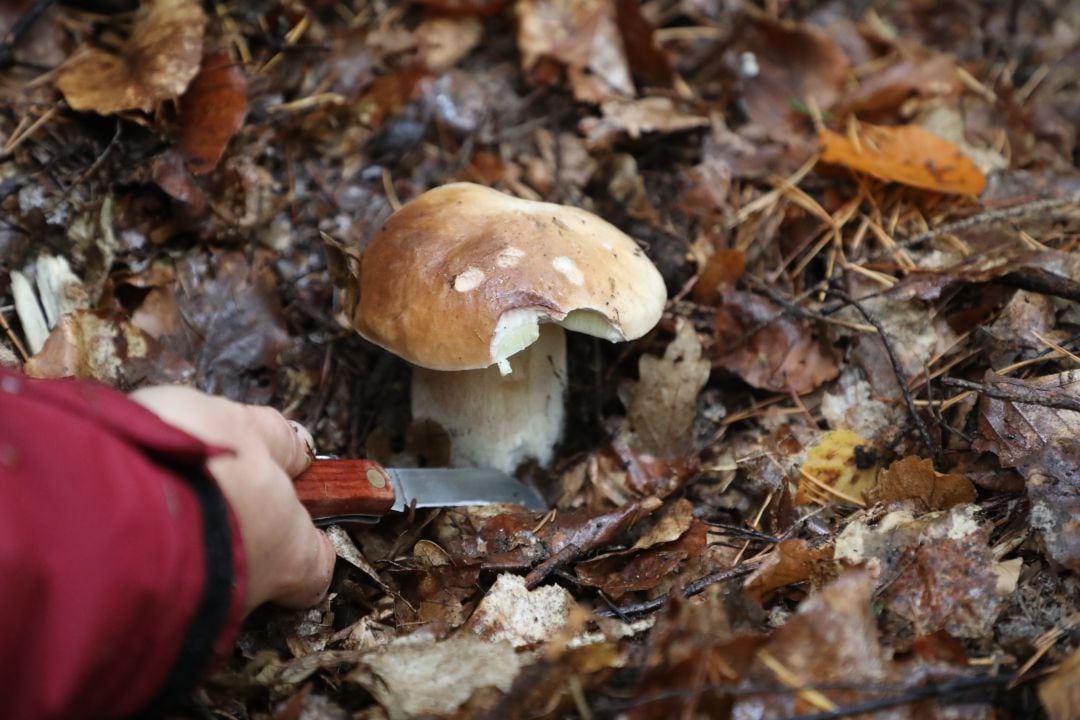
<box><xmin>819</xmin><ymin>125</ymin><xmax>986</xmax><ymax>195</ymax></box>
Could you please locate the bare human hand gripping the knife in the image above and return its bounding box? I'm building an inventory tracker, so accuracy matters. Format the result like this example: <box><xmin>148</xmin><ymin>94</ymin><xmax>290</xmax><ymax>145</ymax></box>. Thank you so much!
<box><xmin>131</xmin><ymin>385</ymin><xmax>335</xmax><ymax>611</ymax></box>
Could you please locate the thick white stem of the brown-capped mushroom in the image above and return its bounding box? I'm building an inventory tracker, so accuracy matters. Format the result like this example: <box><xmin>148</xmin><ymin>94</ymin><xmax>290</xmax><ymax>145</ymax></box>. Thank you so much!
<box><xmin>413</xmin><ymin>324</ymin><xmax>566</xmax><ymax>473</ymax></box>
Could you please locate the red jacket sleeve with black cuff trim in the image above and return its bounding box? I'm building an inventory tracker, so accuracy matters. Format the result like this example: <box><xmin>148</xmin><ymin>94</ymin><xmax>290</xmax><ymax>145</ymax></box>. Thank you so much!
<box><xmin>0</xmin><ymin>370</ymin><xmax>246</xmax><ymax>720</ymax></box>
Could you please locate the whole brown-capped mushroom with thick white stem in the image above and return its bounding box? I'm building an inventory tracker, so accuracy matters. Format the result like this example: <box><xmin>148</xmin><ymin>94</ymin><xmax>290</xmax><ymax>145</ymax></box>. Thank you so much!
<box><xmin>342</xmin><ymin>182</ymin><xmax>667</xmax><ymax>472</ymax></box>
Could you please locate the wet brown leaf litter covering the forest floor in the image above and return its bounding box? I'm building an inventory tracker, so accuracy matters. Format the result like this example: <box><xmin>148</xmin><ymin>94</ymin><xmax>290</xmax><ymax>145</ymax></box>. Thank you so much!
<box><xmin>0</xmin><ymin>0</ymin><xmax>1080</xmax><ymax>720</ymax></box>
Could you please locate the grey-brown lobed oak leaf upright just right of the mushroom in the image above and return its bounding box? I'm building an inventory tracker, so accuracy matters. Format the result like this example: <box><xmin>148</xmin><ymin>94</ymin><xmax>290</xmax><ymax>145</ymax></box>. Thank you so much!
<box><xmin>626</xmin><ymin>320</ymin><xmax>710</xmax><ymax>458</ymax></box>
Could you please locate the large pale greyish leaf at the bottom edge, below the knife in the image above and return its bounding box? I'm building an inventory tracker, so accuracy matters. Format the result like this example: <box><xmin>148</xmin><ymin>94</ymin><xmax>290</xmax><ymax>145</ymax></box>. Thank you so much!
<box><xmin>348</xmin><ymin>633</ymin><xmax>523</xmax><ymax>720</ymax></box>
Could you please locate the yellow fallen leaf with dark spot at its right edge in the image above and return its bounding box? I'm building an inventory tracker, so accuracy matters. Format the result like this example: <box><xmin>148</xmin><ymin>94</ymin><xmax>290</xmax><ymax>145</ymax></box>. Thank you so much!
<box><xmin>795</xmin><ymin>430</ymin><xmax>878</xmax><ymax>505</ymax></box>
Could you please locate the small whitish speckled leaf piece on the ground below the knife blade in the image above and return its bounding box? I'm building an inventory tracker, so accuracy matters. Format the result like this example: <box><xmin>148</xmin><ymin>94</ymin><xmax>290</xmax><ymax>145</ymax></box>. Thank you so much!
<box><xmin>467</xmin><ymin>573</ymin><xmax>577</xmax><ymax>648</ymax></box>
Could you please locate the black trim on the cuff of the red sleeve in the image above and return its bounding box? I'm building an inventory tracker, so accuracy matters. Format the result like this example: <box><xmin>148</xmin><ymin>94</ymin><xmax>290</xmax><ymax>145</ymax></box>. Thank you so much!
<box><xmin>136</xmin><ymin>468</ymin><xmax>235</xmax><ymax>718</ymax></box>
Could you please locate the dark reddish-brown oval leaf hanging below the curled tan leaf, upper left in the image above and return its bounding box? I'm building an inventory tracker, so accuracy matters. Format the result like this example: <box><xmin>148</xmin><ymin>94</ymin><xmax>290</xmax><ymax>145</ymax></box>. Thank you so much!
<box><xmin>177</xmin><ymin>53</ymin><xmax>247</xmax><ymax>175</ymax></box>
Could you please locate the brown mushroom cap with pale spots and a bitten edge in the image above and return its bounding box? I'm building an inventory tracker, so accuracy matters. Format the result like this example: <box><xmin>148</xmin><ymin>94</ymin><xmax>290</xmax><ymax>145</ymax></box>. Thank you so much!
<box><xmin>345</xmin><ymin>182</ymin><xmax>667</xmax><ymax>370</ymax></box>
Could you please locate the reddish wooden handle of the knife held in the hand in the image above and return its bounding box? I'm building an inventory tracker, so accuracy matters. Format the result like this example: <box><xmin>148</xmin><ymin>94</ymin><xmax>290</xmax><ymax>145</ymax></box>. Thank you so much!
<box><xmin>295</xmin><ymin>459</ymin><xmax>394</xmax><ymax>518</ymax></box>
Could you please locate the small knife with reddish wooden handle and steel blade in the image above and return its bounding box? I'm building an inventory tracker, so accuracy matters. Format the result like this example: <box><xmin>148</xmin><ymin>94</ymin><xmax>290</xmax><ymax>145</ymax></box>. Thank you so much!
<box><xmin>295</xmin><ymin>458</ymin><xmax>548</xmax><ymax>525</ymax></box>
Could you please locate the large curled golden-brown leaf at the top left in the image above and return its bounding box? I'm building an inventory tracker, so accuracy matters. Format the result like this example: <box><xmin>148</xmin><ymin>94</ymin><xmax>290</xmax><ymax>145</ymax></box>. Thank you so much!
<box><xmin>56</xmin><ymin>0</ymin><xmax>206</xmax><ymax>114</ymax></box>
